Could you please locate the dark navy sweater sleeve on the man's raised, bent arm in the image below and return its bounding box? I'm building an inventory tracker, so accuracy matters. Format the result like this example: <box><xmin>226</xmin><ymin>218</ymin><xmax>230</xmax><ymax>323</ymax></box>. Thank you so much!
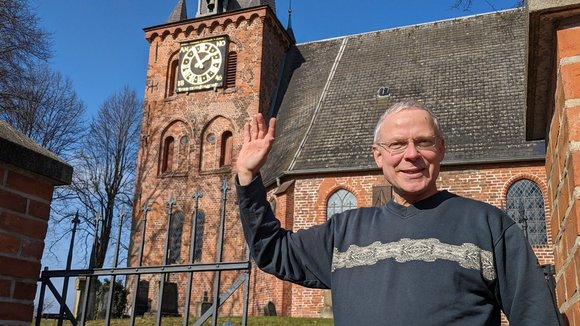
<box><xmin>236</xmin><ymin>175</ymin><xmax>332</xmax><ymax>289</ymax></box>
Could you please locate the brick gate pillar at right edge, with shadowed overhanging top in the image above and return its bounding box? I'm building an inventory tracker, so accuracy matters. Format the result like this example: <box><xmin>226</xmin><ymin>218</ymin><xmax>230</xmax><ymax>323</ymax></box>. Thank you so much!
<box><xmin>526</xmin><ymin>0</ymin><xmax>580</xmax><ymax>325</ymax></box>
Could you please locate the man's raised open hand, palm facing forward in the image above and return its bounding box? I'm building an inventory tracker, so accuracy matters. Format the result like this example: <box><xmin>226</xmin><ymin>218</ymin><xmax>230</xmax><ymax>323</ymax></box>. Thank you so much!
<box><xmin>236</xmin><ymin>113</ymin><xmax>276</xmax><ymax>186</ymax></box>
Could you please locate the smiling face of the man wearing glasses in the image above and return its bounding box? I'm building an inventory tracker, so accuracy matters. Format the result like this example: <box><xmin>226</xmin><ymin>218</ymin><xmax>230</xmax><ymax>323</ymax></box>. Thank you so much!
<box><xmin>373</xmin><ymin>109</ymin><xmax>445</xmax><ymax>205</ymax></box>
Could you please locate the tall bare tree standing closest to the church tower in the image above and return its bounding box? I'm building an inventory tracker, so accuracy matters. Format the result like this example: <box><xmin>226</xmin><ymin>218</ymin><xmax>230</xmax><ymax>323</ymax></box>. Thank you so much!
<box><xmin>66</xmin><ymin>87</ymin><xmax>142</xmax><ymax>268</ymax></box>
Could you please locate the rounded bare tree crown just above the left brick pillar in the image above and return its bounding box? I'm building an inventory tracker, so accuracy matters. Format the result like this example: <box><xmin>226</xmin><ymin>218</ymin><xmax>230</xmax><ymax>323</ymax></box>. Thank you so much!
<box><xmin>0</xmin><ymin>64</ymin><xmax>85</xmax><ymax>155</ymax></box>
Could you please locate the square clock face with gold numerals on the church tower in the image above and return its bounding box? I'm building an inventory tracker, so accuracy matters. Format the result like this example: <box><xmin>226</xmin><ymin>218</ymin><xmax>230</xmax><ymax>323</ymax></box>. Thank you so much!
<box><xmin>177</xmin><ymin>37</ymin><xmax>227</xmax><ymax>92</ymax></box>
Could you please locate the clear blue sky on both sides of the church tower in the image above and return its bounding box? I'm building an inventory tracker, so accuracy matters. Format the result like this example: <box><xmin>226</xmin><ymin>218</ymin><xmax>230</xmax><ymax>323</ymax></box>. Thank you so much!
<box><xmin>34</xmin><ymin>0</ymin><xmax>517</xmax><ymax>117</ymax></box>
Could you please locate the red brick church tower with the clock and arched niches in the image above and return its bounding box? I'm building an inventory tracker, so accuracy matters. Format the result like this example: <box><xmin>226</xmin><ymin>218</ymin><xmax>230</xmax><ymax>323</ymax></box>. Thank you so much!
<box><xmin>129</xmin><ymin>0</ymin><xmax>293</xmax><ymax>314</ymax></box>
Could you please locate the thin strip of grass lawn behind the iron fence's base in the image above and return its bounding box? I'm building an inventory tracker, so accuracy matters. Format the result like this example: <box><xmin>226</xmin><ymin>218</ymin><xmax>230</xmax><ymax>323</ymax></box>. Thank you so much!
<box><xmin>33</xmin><ymin>317</ymin><xmax>334</xmax><ymax>326</ymax></box>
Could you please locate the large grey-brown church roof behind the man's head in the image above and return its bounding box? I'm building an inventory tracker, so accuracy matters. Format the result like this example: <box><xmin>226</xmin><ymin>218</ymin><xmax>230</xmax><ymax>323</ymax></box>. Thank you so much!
<box><xmin>262</xmin><ymin>9</ymin><xmax>545</xmax><ymax>184</ymax></box>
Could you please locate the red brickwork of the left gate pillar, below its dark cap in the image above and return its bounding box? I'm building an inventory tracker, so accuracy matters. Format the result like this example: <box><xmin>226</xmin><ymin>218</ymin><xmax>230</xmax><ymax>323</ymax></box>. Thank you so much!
<box><xmin>0</xmin><ymin>165</ymin><xmax>63</xmax><ymax>325</ymax></box>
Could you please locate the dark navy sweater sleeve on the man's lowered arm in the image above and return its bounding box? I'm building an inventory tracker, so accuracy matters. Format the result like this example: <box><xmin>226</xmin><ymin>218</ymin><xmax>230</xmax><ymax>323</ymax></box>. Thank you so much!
<box><xmin>494</xmin><ymin>217</ymin><xmax>560</xmax><ymax>326</ymax></box>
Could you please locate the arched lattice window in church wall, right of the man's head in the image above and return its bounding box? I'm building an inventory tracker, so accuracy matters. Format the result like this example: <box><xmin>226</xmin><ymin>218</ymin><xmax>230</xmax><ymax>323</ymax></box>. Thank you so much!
<box><xmin>506</xmin><ymin>179</ymin><xmax>548</xmax><ymax>245</ymax></box>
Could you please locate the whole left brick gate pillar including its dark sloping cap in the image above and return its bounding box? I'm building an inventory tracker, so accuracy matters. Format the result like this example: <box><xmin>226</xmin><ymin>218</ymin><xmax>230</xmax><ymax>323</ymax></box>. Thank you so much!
<box><xmin>0</xmin><ymin>121</ymin><xmax>72</xmax><ymax>326</ymax></box>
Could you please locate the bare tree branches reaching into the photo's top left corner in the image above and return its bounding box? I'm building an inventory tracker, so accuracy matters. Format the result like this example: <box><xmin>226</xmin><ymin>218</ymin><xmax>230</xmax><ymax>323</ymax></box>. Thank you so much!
<box><xmin>0</xmin><ymin>0</ymin><xmax>51</xmax><ymax>102</ymax></box>
